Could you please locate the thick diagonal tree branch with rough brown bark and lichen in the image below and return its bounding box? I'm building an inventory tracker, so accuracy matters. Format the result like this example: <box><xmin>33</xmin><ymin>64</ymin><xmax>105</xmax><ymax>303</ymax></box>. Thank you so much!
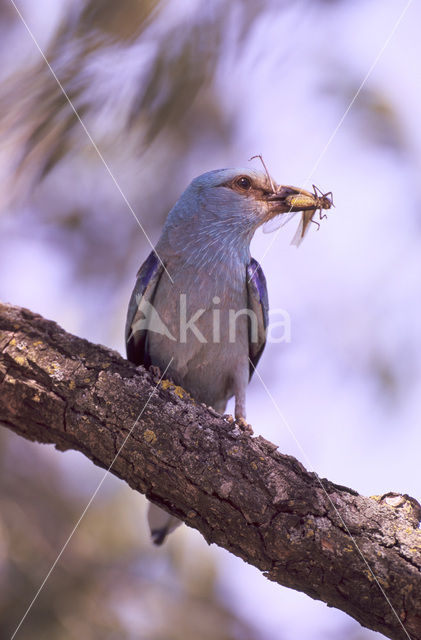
<box><xmin>0</xmin><ymin>305</ymin><xmax>421</xmax><ymax>640</ymax></box>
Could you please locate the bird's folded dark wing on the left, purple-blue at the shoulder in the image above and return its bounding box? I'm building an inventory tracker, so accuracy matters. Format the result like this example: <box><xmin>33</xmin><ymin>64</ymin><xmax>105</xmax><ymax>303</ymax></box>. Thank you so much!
<box><xmin>126</xmin><ymin>251</ymin><xmax>164</xmax><ymax>366</ymax></box>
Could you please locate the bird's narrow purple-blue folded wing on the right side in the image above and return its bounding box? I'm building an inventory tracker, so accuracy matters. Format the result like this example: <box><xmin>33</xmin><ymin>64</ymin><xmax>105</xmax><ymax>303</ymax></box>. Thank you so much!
<box><xmin>246</xmin><ymin>258</ymin><xmax>269</xmax><ymax>378</ymax></box>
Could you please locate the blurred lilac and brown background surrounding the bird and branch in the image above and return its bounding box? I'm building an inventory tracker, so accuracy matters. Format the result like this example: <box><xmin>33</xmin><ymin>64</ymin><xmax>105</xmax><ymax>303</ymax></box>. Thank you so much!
<box><xmin>0</xmin><ymin>0</ymin><xmax>421</xmax><ymax>640</ymax></box>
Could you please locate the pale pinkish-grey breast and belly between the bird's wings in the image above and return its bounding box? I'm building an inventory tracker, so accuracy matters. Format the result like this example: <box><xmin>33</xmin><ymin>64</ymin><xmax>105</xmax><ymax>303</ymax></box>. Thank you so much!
<box><xmin>148</xmin><ymin>269</ymin><xmax>249</xmax><ymax>406</ymax></box>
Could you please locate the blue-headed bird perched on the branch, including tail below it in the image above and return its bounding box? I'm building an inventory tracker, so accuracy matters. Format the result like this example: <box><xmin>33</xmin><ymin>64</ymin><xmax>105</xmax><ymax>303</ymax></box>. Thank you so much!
<box><xmin>125</xmin><ymin>168</ymin><xmax>312</xmax><ymax>545</ymax></box>
